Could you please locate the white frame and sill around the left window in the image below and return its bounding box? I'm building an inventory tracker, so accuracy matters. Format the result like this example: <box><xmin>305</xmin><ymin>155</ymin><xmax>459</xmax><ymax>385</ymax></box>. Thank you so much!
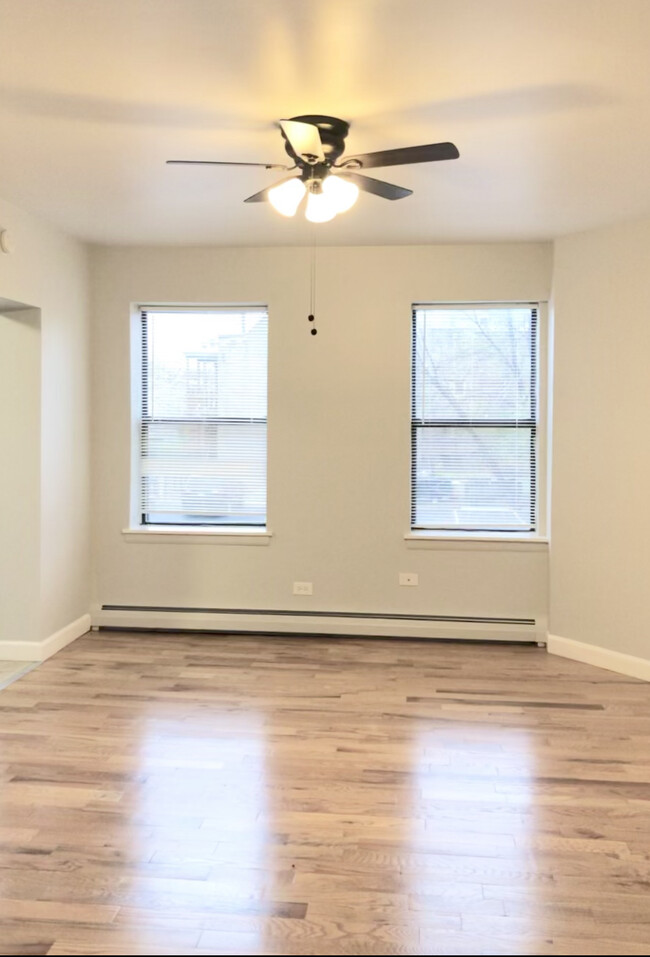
<box><xmin>122</xmin><ymin>302</ymin><xmax>272</xmax><ymax>545</ymax></box>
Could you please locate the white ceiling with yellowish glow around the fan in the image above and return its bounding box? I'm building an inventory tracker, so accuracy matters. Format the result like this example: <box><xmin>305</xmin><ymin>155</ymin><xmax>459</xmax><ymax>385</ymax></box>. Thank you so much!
<box><xmin>0</xmin><ymin>0</ymin><xmax>650</xmax><ymax>245</ymax></box>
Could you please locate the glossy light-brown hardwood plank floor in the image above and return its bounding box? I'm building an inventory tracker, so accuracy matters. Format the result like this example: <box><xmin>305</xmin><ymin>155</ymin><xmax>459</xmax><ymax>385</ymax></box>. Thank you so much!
<box><xmin>0</xmin><ymin>633</ymin><xmax>650</xmax><ymax>954</ymax></box>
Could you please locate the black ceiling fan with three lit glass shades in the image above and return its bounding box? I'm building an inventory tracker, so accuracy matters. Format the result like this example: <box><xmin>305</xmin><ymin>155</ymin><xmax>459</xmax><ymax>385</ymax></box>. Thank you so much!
<box><xmin>167</xmin><ymin>114</ymin><xmax>460</xmax><ymax>223</ymax></box>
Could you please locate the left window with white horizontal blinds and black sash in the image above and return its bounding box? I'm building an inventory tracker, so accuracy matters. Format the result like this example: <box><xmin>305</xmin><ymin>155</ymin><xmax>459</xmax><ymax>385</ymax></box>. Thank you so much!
<box><xmin>139</xmin><ymin>306</ymin><xmax>268</xmax><ymax>526</ymax></box>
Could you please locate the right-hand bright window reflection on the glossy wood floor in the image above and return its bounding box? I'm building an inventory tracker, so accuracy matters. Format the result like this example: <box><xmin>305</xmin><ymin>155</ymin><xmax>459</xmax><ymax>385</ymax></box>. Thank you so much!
<box><xmin>402</xmin><ymin>713</ymin><xmax>535</xmax><ymax>953</ymax></box>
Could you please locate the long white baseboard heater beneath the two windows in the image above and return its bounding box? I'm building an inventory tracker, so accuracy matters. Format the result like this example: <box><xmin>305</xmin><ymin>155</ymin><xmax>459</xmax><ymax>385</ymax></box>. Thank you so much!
<box><xmin>92</xmin><ymin>609</ymin><xmax>546</xmax><ymax>642</ymax></box>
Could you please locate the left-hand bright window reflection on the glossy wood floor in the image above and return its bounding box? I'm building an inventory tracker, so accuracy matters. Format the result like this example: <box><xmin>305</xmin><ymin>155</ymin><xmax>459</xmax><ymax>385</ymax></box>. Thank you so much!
<box><xmin>130</xmin><ymin>704</ymin><xmax>273</xmax><ymax>953</ymax></box>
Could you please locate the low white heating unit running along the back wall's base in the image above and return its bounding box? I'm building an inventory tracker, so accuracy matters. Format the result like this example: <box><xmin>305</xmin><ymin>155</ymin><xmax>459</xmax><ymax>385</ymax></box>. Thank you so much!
<box><xmin>92</xmin><ymin>604</ymin><xmax>546</xmax><ymax>642</ymax></box>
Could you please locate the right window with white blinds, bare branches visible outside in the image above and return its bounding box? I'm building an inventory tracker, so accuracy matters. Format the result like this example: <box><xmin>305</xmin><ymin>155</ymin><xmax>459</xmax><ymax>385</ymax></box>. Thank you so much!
<box><xmin>411</xmin><ymin>304</ymin><xmax>539</xmax><ymax>533</ymax></box>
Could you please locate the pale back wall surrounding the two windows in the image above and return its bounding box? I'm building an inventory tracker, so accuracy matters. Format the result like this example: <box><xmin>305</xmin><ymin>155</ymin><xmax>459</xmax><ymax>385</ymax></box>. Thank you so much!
<box><xmin>91</xmin><ymin>244</ymin><xmax>551</xmax><ymax>618</ymax></box>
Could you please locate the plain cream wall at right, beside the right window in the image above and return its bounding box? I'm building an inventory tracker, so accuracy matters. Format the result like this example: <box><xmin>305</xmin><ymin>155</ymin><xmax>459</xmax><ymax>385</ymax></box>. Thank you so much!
<box><xmin>550</xmin><ymin>221</ymin><xmax>650</xmax><ymax>658</ymax></box>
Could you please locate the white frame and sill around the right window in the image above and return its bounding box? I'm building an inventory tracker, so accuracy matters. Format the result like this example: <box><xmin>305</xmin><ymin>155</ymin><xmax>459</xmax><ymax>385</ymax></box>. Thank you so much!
<box><xmin>404</xmin><ymin>299</ymin><xmax>550</xmax><ymax>550</ymax></box>
